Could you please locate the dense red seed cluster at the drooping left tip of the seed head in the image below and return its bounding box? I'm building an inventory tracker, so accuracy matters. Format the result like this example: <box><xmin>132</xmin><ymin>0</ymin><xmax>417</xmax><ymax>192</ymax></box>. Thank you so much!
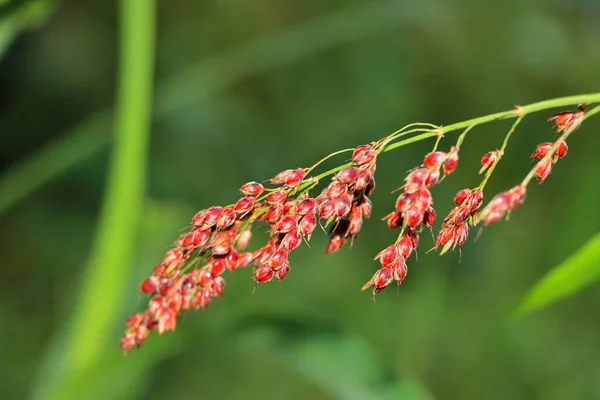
<box><xmin>121</xmin><ymin>182</ymin><xmax>264</xmax><ymax>352</ymax></box>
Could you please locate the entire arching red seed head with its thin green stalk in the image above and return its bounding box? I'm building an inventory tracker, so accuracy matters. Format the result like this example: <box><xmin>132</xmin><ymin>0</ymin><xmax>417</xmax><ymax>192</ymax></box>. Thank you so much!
<box><xmin>121</xmin><ymin>94</ymin><xmax>600</xmax><ymax>352</ymax></box>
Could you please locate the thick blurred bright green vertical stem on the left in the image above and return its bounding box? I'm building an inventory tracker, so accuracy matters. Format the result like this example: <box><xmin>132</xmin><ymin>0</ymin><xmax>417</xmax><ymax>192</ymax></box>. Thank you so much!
<box><xmin>65</xmin><ymin>0</ymin><xmax>155</xmax><ymax>376</ymax></box>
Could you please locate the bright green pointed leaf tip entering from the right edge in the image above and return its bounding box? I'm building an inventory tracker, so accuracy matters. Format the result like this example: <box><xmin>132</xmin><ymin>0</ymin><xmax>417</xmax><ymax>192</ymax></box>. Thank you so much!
<box><xmin>513</xmin><ymin>233</ymin><xmax>600</xmax><ymax>317</ymax></box>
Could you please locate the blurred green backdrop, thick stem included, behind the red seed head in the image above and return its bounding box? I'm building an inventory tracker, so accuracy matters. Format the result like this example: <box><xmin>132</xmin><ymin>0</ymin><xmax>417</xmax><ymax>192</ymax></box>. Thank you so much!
<box><xmin>0</xmin><ymin>0</ymin><xmax>600</xmax><ymax>400</ymax></box>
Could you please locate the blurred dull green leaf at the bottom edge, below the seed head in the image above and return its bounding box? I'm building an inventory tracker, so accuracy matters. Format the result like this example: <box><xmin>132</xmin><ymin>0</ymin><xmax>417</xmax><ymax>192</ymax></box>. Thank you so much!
<box><xmin>236</xmin><ymin>316</ymin><xmax>433</xmax><ymax>400</ymax></box>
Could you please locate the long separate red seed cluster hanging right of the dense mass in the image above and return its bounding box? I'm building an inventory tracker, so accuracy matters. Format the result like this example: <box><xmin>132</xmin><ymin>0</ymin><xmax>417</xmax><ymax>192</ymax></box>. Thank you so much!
<box><xmin>362</xmin><ymin>146</ymin><xmax>459</xmax><ymax>295</ymax></box>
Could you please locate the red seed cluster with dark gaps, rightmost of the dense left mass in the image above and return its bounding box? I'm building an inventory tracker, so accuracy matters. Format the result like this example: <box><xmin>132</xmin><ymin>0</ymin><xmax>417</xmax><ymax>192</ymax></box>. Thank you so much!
<box><xmin>316</xmin><ymin>145</ymin><xmax>377</xmax><ymax>254</ymax></box>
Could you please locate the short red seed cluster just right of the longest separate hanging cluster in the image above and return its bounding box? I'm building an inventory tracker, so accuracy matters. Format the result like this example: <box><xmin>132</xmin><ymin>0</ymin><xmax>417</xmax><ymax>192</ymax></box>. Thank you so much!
<box><xmin>435</xmin><ymin>189</ymin><xmax>483</xmax><ymax>254</ymax></box>
